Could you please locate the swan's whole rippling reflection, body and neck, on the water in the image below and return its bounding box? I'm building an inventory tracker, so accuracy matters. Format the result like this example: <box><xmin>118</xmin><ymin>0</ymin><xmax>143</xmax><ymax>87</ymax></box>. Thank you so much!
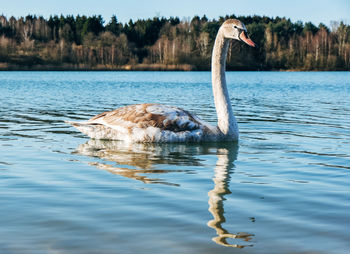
<box><xmin>76</xmin><ymin>139</ymin><xmax>253</xmax><ymax>248</ymax></box>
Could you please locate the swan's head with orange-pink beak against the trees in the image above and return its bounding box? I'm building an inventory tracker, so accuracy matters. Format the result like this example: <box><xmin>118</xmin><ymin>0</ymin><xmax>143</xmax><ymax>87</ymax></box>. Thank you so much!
<box><xmin>220</xmin><ymin>19</ymin><xmax>256</xmax><ymax>47</ymax></box>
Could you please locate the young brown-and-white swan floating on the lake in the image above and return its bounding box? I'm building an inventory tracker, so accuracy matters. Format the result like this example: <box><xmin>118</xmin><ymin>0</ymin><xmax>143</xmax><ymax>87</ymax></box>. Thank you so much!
<box><xmin>66</xmin><ymin>19</ymin><xmax>255</xmax><ymax>143</ymax></box>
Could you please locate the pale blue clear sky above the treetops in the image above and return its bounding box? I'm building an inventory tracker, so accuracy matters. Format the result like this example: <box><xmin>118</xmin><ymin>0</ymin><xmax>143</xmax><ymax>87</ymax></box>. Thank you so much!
<box><xmin>0</xmin><ymin>0</ymin><xmax>350</xmax><ymax>26</ymax></box>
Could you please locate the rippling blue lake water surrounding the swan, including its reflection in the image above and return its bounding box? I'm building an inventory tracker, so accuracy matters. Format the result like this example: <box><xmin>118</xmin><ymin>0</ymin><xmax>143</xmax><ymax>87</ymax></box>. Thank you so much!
<box><xmin>0</xmin><ymin>72</ymin><xmax>350</xmax><ymax>254</ymax></box>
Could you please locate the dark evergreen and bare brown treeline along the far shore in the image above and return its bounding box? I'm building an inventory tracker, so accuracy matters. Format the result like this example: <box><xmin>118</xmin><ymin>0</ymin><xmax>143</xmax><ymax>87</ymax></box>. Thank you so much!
<box><xmin>0</xmin><ymin>15</ymin><xmax>350</xmax><ymax>70</ymax></box>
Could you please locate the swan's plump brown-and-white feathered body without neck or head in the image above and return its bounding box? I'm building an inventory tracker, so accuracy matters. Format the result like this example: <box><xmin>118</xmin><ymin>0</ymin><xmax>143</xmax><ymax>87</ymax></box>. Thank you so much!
<box><xmin>71</xmin><ymin>104</ymin><xmax>220</xmax><ymax>142</ymax></box>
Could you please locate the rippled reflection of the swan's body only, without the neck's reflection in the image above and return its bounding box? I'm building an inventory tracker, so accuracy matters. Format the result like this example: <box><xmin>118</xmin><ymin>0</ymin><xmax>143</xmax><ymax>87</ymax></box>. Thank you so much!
<box><xmin>76</xmin><ymin>139</ymin><xmax>201</xmax><ymax>186</ymax></box>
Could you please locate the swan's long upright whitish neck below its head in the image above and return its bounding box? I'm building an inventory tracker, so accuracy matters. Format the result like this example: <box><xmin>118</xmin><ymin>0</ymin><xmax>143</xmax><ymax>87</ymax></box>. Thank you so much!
<box><xmin>211</xmin><ymin>30</ymin><xmax>238</xmax><ymax>140</ymax></box>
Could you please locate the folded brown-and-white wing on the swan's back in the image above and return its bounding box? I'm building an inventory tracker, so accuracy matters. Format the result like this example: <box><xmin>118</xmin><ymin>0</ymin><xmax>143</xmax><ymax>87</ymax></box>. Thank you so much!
<box><xmin>87</xmin><ymin>104</ymin><xmax>209</xmax><ymax>132</ymax></box>
